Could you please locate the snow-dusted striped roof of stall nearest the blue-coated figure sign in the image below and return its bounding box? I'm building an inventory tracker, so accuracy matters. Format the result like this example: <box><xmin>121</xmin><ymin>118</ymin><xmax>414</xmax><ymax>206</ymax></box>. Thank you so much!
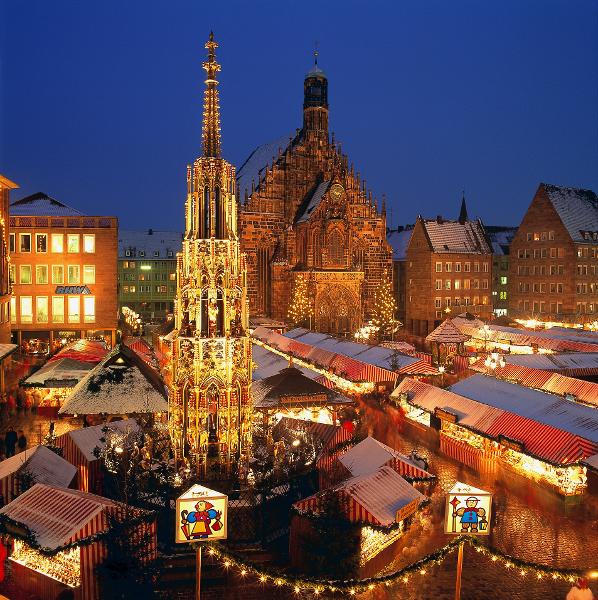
<box><xmin>335</xmin><ymin>467</ymin><xmax>426</xmax><ymax>525</ymax></box>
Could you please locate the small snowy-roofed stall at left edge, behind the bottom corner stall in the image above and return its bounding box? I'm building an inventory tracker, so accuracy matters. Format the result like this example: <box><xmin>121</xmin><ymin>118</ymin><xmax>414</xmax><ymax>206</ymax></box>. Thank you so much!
<box><xmin>0</xmin><ymin>446</ymin><xmax>77</xmax><ymax>505</ymax></box>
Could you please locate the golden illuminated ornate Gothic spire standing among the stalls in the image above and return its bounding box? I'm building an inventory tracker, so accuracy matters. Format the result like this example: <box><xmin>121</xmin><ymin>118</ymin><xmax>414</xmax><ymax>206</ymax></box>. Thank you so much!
<box><xmin>169</xmin><ymin>33</ymin><xmax>251</xmax><ymax>476</ymax></box>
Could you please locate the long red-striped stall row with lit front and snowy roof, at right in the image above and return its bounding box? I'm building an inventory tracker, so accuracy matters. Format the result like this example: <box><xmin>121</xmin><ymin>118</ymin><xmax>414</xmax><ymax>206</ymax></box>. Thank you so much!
<box><xmin>391</xmin><ymin>374</ymin><xmax>598</xmax><ymax>496</ymax></box>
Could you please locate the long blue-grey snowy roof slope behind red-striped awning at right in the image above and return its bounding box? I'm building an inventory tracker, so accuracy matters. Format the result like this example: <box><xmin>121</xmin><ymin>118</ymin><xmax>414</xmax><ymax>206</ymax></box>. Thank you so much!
<box><xmin>448</xmin><ymin>374</ymin><xmax>598</xmax><ymax>443</ymax></box>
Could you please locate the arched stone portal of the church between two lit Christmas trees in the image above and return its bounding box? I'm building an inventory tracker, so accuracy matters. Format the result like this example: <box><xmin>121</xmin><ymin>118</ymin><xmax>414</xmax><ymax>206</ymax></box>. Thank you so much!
<box><xmin>316</xmin><ymin>284</ymin><xmax>360</xmax><ymax>335</ymax></box>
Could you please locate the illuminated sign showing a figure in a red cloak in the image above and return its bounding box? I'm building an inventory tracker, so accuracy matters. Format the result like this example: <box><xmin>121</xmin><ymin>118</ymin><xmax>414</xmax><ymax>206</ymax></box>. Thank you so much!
<box><xmin>175</xmin><ymin>485</ymin><xmax>228</xmax><ymax>544</ymax></box>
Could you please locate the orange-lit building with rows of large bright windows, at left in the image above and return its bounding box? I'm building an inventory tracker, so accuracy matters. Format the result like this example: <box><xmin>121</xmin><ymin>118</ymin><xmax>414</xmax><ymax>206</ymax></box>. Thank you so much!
<box><xmin>9</xmin><ymin>193</ymin><xmax>118</xmax><ymax>352</ymax></box>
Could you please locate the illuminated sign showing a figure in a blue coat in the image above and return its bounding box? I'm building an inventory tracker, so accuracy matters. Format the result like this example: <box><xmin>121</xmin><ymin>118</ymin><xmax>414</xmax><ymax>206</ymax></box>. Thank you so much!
<box><xmin>444</xmin><ymin>481</ymin><xmax>492</xmax><ymax>535</ymax></box>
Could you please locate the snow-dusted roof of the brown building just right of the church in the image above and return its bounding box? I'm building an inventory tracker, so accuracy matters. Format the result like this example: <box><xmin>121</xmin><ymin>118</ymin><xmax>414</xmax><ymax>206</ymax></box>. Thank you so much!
<box><xmin>422</xmin><ymin>219</ymin><xmax>492</xmax><ymax>254</ymax></box>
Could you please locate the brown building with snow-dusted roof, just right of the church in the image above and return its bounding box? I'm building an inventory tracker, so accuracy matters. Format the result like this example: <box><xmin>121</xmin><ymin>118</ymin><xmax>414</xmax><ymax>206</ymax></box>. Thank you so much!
<box><xmin>405</xmin><ymin>216</ymin><xmax>492</xmax><ymax>337</ymax></box>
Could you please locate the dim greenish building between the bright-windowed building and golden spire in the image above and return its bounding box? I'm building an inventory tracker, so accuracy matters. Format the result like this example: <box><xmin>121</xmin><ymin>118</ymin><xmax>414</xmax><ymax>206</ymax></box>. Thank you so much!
<box><xmin>118</xmin><ymin>229</ymin><xmax>183</xmax><ymax>321</ymax></box>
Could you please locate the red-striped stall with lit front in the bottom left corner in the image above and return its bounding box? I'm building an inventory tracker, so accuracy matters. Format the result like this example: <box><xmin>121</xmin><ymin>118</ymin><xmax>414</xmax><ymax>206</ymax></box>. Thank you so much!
<box><xmin>0</xmin><ymin>483</ymin><xmax>157</xmax><ymax>600</ymax></box>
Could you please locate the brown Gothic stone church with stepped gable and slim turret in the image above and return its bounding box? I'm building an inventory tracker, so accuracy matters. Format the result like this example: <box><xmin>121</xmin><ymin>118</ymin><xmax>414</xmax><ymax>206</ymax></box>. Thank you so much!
<box><xmin>237</xmin><ymin>55</ymin><xmax>392</xmax><ymax>334</ymax></box>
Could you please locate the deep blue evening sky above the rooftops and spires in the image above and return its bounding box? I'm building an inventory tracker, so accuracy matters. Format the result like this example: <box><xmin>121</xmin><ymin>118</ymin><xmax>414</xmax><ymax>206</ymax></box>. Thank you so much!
<box><xmin>0</xmin><ymin>0</ymin><xmax>598</xmax><ymax>229</ymax></box>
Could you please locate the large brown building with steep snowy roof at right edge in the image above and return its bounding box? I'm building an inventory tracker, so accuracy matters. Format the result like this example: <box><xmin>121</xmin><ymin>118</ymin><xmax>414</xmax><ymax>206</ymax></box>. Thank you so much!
<box><xmin>509</xmin><ymin>183</ymin><xmax>598</xmax><ymax>324</ymax></box>
